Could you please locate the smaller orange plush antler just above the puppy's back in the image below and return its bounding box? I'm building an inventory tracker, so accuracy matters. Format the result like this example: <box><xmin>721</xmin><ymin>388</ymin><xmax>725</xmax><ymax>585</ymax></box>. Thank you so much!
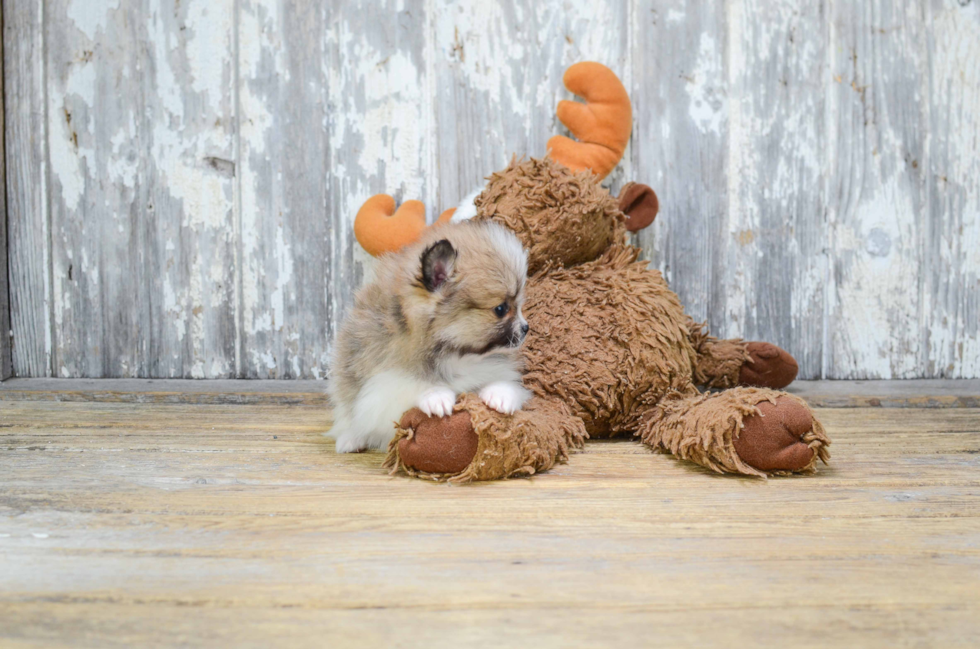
<box><xmin>354</xmin><ymin>194</ymin><xmax>455</xmax><ymax>257</ymax></box>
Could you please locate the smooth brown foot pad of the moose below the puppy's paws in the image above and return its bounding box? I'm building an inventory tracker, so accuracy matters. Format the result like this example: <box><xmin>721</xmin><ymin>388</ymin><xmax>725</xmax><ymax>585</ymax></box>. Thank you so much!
<box><xmin>398</xmin><ymin>408</ymin><xmax>478</xmax><ymax>473</ymax></box>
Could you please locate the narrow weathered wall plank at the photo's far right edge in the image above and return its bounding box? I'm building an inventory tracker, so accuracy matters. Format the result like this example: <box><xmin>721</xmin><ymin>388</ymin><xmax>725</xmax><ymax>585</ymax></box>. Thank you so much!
<box><xmin>918</xmin><ymin>0</ymin><xmax>980</xmax><ymax>378</ymax></box>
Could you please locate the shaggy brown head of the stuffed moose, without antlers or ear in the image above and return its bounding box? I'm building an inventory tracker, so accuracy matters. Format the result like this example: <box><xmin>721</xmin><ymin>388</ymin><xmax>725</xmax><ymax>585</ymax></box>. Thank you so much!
<box><xmin>475</xmin><ymin>158</ymin><xmax>626</xmax><ymax>273</ymax></box>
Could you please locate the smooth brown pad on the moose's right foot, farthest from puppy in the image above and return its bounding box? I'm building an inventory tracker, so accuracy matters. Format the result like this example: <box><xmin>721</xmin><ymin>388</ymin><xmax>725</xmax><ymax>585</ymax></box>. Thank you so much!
<box><xmin>732</xmin><ymin>397</ymin><xmax>819</xmax><ymax>471</ymax></box>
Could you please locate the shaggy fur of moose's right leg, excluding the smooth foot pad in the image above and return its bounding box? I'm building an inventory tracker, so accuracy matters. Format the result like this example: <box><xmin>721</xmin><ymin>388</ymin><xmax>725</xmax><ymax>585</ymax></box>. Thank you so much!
<box><xmin>637</xmin><ymin>388</ymin><xmax>830</xmax><ymax>477</ymax></box>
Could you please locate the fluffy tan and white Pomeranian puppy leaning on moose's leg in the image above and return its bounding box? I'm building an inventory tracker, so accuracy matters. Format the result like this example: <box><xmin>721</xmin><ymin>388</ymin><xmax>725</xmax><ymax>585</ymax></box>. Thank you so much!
<box><xmin>328</xmin><ymin>221</ymin><xmax>530</xmax><ymax>453</ymax></box>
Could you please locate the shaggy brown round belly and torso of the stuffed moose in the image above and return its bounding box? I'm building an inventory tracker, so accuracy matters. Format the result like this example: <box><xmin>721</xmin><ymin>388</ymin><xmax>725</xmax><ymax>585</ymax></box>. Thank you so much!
<box><xmin>523</xmin><ymin>246</ymin><xmax>695</xmax><ymax>437</ymax></box>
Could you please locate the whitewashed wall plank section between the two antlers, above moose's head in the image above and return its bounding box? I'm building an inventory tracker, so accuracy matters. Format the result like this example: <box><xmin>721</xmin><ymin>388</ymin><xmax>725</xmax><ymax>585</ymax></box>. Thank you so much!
<box><xmin>429</xmin><ymin>0</ymin><xmax>631</xmax><ymax>213</ymax></box>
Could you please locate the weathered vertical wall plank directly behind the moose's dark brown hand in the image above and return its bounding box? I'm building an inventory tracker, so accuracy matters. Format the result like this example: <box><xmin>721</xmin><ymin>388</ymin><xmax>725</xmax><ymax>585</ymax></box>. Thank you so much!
<box><xmin>712</xmin><ymin>0</ymin><xmax>828</xmax><ymax>378</ymax></box>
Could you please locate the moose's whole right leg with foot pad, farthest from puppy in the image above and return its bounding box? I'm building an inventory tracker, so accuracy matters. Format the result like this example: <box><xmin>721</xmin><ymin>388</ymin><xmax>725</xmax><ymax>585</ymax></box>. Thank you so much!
<box><xmin>637</xmin><ymin>388</ymin><xmax>830</xmax><ymax>476</ymax></box>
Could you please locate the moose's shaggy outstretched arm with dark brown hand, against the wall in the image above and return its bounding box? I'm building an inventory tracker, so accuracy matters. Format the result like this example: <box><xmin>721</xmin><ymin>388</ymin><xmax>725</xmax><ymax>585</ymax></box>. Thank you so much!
<box><xmin>688</xmin><ymin>320</ymin><xmax>799</xmax><ymax>390</ymax></box>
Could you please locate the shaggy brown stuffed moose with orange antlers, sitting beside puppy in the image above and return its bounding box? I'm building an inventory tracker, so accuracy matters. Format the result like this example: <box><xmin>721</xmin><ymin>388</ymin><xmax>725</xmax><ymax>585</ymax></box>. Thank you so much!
<box><xmin>354</xmin><ymin>62</ymin><xmax>830</xmax><ymax>482</ymax></box>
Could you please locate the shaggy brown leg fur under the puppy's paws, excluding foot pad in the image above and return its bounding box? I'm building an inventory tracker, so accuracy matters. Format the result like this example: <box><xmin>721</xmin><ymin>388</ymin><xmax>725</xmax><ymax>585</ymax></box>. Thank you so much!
<box><xmin>384</xmin><ymin>394</ymin><xmax>588</xmax><ymax>482</ymax></box>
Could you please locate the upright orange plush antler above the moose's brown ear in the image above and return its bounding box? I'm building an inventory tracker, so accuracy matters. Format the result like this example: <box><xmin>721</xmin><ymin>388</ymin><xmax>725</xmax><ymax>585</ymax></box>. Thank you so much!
<box><xmin>548</xmin><ymin>61</ymin><xmax>633</xmax><ymax>179</ymax></box>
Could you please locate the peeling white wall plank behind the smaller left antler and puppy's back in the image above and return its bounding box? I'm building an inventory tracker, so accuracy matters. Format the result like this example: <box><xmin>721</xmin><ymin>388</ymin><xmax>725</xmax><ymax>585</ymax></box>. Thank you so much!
<box><xmin>322</xmin><ymin>0</ymin><xmax>432</xmax><ymax>377</ymax></box>
